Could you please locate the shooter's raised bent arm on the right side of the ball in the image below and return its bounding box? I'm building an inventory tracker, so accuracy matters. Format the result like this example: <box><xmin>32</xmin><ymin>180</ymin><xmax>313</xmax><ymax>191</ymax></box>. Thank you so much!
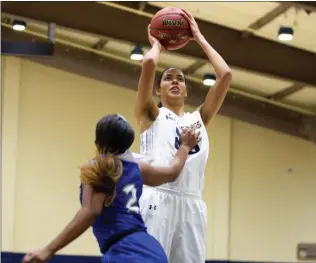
<box><xmin>183</xmin><ymin>10</ymin><xmax>232</xmax><ymax>126</ymax></box>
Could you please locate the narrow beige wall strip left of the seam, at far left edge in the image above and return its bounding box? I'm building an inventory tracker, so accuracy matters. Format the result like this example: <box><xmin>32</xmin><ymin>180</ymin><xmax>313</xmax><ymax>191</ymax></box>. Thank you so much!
<box><xmin>1</xmin><ymin>57</ymin><xmax>21</xmax><ymax>251</ymax></box>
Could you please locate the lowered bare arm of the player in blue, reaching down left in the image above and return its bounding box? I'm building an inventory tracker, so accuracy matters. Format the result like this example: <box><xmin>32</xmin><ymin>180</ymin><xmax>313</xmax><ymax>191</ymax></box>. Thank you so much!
<box><xmin>23</xmin><ymin>185</ymin><xmax>105</xmax><ymax>263</ymax></box>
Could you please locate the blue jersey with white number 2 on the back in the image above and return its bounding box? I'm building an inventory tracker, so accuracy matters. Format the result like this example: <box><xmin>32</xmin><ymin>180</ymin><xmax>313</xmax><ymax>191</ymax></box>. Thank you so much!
<box><xmin>80</xmin><ymin>155</ymin><xmax>146</xmax><ymax>253</ymax></box>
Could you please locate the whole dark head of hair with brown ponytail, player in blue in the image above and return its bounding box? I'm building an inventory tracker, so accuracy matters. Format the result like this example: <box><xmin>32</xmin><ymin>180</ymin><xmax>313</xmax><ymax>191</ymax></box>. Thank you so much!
<box><xmin>80</xmin><ymin>114</ymin><xmax>135</xmax><ymax>205</ymax></box>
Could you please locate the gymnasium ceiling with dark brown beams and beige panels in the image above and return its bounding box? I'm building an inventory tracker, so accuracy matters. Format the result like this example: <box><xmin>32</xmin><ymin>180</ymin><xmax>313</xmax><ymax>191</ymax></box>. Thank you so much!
<box><xmin>1</xmin><ymin>2</ymin><xmax>316</xmax><ymax>142</ymax></box>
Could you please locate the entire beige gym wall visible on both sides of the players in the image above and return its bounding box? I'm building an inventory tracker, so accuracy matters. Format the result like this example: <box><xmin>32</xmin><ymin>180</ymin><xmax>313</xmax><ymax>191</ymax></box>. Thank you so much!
<box><xmin>2</xmin><ymin>58</ymin><xmax>316</xmax><ymax>261</ymax></box>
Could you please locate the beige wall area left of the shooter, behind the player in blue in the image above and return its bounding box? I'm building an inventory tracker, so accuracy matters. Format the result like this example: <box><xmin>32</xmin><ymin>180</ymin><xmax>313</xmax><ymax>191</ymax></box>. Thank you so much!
<box><xmin>2</xmin><ymin>58</ymin><xmax>139</xmax><ymax>254</ymax></box>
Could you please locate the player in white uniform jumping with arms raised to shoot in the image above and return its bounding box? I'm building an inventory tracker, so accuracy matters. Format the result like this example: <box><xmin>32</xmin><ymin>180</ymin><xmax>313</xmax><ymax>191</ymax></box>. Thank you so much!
<box><xmin>134</xmin><ymin>10</ymin><xmax>232</xmax><ymax>263</ymax></box>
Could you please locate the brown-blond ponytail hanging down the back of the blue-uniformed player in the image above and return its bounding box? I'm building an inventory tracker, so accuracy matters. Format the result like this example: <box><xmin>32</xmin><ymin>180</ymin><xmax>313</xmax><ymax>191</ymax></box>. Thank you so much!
<box><xmin>80</xmin><ymin>153</ymin><xmax>123</xmax><ymax>206</ymax></box>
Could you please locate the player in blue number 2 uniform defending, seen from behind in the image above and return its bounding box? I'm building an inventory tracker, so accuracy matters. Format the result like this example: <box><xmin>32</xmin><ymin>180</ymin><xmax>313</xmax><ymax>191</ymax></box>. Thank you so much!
<box><xmin>23</xmin><ymin>115</ymin><xmax>199</xmax><ymax>263</ymax></box>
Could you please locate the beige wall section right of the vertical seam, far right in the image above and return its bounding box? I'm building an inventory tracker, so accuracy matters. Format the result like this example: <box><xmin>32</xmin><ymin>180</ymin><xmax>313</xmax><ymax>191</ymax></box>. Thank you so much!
<box><xmin>230</xmin><ymin>121</ymin><xmax>316</xmax><ymax>261</ymax></box>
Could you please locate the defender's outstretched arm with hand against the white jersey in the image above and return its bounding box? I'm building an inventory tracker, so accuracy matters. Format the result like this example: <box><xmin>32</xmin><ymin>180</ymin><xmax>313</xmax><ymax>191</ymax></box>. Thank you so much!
<box><xmin>138</xmin><ymin>130</ymin><xmax>200</xmax><ymax>186</ymax></box>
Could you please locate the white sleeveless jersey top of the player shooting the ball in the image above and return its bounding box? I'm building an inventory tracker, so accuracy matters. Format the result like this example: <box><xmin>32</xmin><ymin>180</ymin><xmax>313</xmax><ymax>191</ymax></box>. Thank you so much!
<box><xmin>141</xmin><ymin>107</ymin><xmax>209</xmax><ymax>194</ymax></box>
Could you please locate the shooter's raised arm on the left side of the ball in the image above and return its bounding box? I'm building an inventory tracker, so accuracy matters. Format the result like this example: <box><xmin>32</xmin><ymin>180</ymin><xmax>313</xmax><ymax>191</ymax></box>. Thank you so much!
<box><xmin>134</xmin><ymin>26</ymin><xmax>164</xmax><ymax>130</ymax></box>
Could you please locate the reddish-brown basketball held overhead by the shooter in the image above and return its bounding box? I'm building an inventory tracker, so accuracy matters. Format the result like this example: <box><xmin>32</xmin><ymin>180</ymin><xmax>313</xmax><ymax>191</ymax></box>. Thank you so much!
<box><xmin>150</xmin><ymin>7</ymin><xmax>192</xmax><ymax>50</ymax></box>
